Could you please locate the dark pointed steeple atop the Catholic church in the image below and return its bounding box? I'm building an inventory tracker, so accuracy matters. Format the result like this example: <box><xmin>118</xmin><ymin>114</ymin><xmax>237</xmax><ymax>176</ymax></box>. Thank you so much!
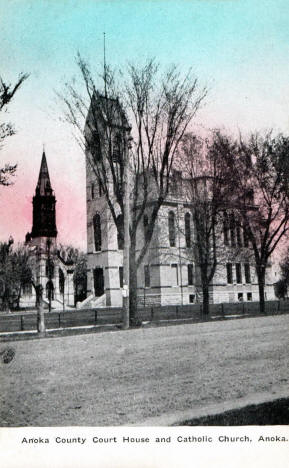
<box><xmin>31</xmin><ymin>150</ymin><xmax>57</xmax><ymax>238</ymax></box>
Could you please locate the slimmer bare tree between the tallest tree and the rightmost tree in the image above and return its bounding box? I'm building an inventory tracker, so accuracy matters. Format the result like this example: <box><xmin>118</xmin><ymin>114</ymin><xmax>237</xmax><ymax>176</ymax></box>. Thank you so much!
<box><xmin>180</xmin><ymin>133</ymin><xmax>236</xmax><ymax>314</ymax></box>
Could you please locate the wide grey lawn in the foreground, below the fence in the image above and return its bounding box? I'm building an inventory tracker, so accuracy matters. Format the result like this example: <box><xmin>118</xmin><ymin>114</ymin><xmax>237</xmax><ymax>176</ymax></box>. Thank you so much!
<box><xmin>0</xmin><ymin>315</ymin><xmax>289</xmax><ymax>426</ymax></box>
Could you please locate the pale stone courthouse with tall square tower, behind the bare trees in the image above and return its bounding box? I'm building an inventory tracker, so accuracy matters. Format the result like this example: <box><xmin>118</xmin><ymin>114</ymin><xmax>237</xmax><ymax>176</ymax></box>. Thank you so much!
<box><xmin>85</xmin><ymin>94</ymin><xmax>275</xmax><ymax>306</ymax></box>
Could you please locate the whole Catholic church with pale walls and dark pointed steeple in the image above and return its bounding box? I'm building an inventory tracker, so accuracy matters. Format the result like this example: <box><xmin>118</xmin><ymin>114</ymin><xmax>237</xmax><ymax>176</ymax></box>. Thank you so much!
<box><xmin>21</xmin><ymin>151</ymin><xmax>74</xmax><ymax>308</ymax></box>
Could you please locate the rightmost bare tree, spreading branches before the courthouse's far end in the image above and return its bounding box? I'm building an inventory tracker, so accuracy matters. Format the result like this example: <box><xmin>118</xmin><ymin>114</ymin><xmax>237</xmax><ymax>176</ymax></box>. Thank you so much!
<box><xmin>216</xmin><ymin>132</ymin><xmax>289</xmax><ymax>313</ymax></box>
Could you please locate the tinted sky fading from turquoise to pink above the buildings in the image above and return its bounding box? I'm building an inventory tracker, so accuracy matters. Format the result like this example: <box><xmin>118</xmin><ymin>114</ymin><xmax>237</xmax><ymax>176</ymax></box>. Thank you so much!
<box><xmin>0</xmin><ymin>0</ymin><xmax>289</xmax><ymax>246</ymax></box>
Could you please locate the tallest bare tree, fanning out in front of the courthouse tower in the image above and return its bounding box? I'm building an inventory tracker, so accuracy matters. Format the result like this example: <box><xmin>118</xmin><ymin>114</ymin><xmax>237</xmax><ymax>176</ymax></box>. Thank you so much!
<box><xmin>61</xmin><ymin>57</ymin><xmax>207</xmax><ymax>318</ymax></box>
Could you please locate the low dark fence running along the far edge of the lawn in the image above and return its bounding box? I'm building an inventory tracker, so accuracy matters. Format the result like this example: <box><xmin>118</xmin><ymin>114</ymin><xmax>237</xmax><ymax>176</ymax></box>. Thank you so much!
<box><xmin>0</xmin><ymin>301</ymin><xmax>289</xmax><ymax>332</ymax></box>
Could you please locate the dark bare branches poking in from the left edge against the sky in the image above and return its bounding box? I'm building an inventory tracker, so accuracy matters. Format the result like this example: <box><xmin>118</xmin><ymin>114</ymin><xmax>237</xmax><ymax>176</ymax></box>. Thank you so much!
<box><xmin>0</xmin><ymin>73</ymin><xmax>28</xmax><ymax>185</ymax></box>
